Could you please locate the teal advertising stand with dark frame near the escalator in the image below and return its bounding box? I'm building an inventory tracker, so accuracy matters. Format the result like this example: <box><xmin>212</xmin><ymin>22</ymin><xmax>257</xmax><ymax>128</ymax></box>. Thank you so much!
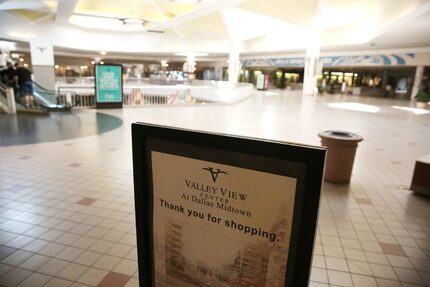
<box><xmin>94</xmin><ymin>64</ymin><xmax>123</xmax><ymax>109</ymax></box>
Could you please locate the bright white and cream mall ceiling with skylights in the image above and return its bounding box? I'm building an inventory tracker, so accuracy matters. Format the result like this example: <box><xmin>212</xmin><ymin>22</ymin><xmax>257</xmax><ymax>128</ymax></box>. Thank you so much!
<box><xmin>0</xmin><ymin>0</ymin><xmax>430</xmax><ymax>58</ymax></box>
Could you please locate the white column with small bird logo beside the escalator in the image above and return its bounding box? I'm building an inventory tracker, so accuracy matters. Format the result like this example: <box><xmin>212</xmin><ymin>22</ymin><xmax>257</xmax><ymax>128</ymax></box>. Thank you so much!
<box><xmin>30</xmin><ymin>38</ymin><xmax>55</xmax><ymax>90</ymax></box>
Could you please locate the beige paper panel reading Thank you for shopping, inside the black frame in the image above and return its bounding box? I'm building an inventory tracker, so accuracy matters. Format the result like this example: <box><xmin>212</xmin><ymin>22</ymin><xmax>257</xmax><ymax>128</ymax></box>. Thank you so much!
<box><xmin>151</xmin><ymin>151</ymin><xmax>296</xmax><ymax>287</ymax></box>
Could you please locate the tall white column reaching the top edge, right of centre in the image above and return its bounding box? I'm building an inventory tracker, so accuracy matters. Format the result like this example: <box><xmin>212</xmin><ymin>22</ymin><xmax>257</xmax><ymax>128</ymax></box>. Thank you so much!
<box><xmin>303</xmin><ymin>0</ymin><xmax>324</xmax><ymax>95</ymax></box>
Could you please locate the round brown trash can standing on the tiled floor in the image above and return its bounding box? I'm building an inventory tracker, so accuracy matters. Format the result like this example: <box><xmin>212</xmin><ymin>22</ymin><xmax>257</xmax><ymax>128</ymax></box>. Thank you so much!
<box><xmin>318</xmin><ymin>130</ymin><xmax>363</xmax><ymax>183</ymax></box>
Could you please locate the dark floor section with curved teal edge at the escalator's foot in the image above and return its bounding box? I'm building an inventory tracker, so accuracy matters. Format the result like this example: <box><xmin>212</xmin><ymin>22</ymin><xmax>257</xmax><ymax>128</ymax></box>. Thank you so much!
<box><xmin>0</xmin><ymin>111</ymin><xmax>122</xmax><ymax>146</ymax></box>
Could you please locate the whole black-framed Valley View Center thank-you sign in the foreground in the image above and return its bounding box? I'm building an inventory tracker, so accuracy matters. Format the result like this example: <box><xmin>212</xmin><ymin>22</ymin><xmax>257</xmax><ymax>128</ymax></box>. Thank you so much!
<box><xmin>132</xmin><ymin>123</ymin><xmax>325</xmax><ymax>287</ymax></box>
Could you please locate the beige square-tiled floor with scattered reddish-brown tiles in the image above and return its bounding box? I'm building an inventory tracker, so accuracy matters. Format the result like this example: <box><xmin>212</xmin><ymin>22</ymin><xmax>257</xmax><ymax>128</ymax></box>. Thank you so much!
<box><xmin>0</xmin><ymin>92</ymin><xmax>430</xmax><ymax>287</ymax></box>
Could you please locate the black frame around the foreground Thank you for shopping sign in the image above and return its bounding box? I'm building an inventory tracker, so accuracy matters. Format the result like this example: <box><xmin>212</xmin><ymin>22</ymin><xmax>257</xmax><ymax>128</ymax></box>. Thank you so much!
<box><xmin>132</xmin><ymin>123</ymin><xmax>326</xmax><ymax>287</ymax></box>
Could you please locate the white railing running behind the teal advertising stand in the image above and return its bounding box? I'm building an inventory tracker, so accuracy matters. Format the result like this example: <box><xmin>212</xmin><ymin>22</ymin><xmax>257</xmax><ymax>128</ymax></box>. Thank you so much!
<box><xmin>57</xmin><ymin>81</ymin><xmax>253</xmax><ymax>107</ymax></box>
